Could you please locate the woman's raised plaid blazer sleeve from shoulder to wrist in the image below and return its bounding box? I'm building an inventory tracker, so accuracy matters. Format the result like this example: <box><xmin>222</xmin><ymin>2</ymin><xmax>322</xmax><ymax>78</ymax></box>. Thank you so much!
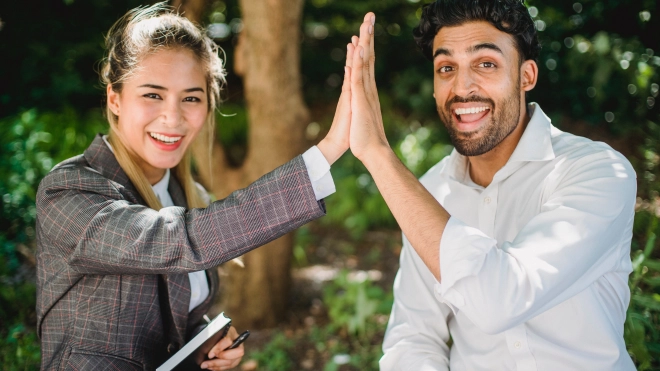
<box><xmin>37</xmin><ymin>156</ymin><xmax>325</xmax><ymax>274</ymax></box>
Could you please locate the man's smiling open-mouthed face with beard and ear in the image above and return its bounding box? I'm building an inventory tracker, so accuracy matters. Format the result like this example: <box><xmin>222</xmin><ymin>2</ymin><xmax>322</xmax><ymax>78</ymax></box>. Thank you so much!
<box><xmin>433</xmin><ymin>22</ymin><xmax>536</xmax><ymax>156</ymax></box>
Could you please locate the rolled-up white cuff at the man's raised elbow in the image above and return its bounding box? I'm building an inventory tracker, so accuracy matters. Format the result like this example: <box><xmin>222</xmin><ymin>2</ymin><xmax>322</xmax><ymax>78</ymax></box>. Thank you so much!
<box><xmin>436</xmin><ymin>217</ymin><xmax>497</xmax><ymax>309</ymax></box>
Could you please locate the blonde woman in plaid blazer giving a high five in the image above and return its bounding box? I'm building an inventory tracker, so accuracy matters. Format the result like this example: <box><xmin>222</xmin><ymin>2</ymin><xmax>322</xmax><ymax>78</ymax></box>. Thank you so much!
<box><xmin>37</xmin><ymin>4</ymin><xmax>350</xmax><ymax>370</ymax></box>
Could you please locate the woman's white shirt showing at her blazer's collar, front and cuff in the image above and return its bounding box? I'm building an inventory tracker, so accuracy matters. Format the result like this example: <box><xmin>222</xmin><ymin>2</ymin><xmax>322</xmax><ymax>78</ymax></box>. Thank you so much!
<box><xmin>103</xmin><ymin>135</ymin><xmax>335</xmax><ymax>312</ymax></box>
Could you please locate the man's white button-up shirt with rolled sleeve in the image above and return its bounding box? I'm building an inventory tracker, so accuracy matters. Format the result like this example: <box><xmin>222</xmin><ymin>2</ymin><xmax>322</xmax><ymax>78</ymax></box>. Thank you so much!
<box><xmin>380</xmin><ymin>103</ymin><xmax>636</xmax><ymax>371</ymax></box>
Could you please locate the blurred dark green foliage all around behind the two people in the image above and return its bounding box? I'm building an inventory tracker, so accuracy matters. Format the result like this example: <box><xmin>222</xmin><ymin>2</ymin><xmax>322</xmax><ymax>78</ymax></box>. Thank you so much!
<box><xmin>0</xmin><ymin>0</ymin><xmax>660</xmax><ymax>370</ymax></box>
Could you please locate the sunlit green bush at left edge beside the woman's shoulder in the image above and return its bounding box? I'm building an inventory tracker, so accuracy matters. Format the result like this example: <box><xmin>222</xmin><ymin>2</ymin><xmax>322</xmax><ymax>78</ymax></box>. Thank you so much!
<box><xmin>0</xmin><ymin>109</ymin><xmax>107</xmax><ymax>370</ymax></box>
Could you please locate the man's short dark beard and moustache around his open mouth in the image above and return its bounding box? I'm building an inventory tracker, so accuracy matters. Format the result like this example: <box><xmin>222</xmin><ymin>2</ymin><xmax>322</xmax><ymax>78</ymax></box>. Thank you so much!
<box><xmin>436</xmin><ymin>84</ymin><xmax>520</xmax><ymax>156</ymax></box>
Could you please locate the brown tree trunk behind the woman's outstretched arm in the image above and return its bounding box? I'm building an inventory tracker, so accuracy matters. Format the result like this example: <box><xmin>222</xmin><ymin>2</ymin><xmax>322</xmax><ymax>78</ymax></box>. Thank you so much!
<box><xmin>189</xmin><ymin>0</ymin><xmax>309</xmax><ymax>328</ymax></box>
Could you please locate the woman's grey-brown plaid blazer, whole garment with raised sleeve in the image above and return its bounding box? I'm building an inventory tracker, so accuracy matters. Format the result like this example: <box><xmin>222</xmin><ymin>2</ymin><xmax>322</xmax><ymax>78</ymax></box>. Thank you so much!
<box><xmin>36</xmin><ymin>135</ymin><xmax>325</xmax><ymax>370</ymax></box>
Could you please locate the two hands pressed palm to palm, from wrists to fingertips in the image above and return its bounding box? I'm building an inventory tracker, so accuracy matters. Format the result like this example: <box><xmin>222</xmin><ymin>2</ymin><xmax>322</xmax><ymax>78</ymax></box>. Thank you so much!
<box><xmin>318</xmin><ymin>12</ymin><xmax>391</xmax><ymax>165</ymax></box>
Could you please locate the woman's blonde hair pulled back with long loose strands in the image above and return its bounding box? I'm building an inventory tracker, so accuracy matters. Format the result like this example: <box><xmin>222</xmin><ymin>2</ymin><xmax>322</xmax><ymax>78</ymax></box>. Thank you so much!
<box><xmin>100</xmin><ymin>2</ymin><xmax>225</xmax><ymax>210</ymax></box>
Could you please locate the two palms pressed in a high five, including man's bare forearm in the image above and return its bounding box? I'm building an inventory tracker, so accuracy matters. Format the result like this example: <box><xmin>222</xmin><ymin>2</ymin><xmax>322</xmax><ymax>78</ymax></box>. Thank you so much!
<box><xmin>318</xmin><ymin>12</ymin><xmax>450</xmax><ymax>280</ymax></box>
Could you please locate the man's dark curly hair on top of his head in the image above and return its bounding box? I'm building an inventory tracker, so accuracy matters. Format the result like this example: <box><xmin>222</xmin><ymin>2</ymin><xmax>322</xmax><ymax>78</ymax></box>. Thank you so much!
<box><xmin>413</xmin><ymin>0</ymin><xmax>541</xmax><ymax>63</ymax></box>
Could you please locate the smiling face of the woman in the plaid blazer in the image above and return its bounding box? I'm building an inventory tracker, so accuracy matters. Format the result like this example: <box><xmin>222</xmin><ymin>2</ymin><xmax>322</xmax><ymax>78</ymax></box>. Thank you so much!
<box><xmin>107</xmin><ymin>49</ymin><xmax>208</xmax><ymax>185</ymax></box>
